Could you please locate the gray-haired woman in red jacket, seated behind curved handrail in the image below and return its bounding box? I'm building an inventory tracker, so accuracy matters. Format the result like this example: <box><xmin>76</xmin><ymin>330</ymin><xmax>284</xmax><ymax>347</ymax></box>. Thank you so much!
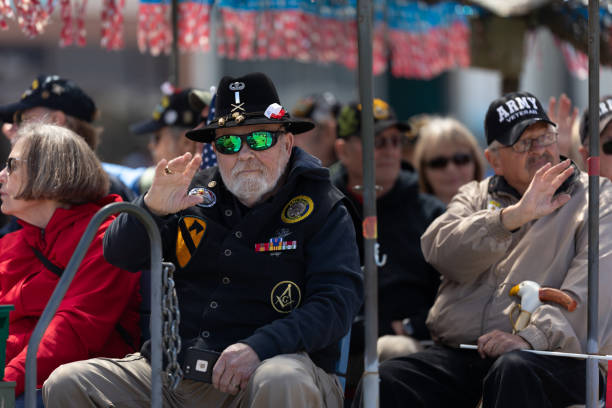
<box><xmin>0</xmin><ymin>123</ymin><xmax>140</xmax><ymax>395</ymax></box>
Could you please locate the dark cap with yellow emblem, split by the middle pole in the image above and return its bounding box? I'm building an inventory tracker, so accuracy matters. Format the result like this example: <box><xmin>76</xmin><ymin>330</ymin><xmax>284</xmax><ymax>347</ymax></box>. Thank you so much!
<box><xmin>337</xmin><ymin>98</ymin><xmax>410</xmax><ymax>139</ymax></box>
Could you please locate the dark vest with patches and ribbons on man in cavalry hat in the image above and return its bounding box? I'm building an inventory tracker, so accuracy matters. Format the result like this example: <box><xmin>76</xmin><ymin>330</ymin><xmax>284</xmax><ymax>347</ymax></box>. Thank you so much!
<box><xmin>162</xmin><ymin>158</ymin><xmax>344</xmax><ymax>371</ymax></box>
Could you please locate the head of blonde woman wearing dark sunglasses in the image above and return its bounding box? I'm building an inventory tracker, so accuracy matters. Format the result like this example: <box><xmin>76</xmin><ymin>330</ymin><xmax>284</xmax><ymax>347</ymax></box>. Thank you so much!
<box><xmin>414</xmin><ymin>117</ymin><xmax>485</xmax><ymax>204</ymax></box>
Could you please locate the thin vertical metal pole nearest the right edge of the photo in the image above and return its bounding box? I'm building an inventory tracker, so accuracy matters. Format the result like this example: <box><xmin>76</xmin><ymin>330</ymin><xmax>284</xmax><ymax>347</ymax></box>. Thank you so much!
<box><xmin>586</xmin><ymin>0</ymin><xmax>599</xmax><ymax>408</ymax></box>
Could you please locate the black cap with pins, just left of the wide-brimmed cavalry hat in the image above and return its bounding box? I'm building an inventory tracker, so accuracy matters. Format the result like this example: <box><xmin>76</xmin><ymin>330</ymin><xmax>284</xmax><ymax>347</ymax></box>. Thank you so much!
<box><xmin>130</xmin><ymin>88</ymin><xmax>210</xmax><ymax>135</ymax></box>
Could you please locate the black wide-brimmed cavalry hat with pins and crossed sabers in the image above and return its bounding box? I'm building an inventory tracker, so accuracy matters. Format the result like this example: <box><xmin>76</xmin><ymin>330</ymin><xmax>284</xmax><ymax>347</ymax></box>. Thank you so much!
<box><xmin>186</xmin><ymin>72</ymin><xmax>314</xmax><ymax>142</ymax></box>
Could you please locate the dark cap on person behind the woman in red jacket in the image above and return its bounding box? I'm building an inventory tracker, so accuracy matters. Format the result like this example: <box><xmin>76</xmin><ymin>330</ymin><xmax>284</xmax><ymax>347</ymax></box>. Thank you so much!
<box><xmin>0</xmin><ymin>75</ymin><xmax>98</xmax><ymax>123</ymax></box>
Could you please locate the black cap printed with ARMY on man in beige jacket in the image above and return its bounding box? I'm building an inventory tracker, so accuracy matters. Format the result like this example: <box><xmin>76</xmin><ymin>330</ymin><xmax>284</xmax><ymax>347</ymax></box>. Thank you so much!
<box><xmin>485</xmin><ymin>92</ymin><xmax>557</xmax><ymax>146</ymax></box>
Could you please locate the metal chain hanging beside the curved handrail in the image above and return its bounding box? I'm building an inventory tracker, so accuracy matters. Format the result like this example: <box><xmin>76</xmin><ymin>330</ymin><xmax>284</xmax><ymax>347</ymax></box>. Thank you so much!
<box><xmin>162</xmin><ymin>262</ymin><xmax>183</xmax><ymax>390</ymax></box>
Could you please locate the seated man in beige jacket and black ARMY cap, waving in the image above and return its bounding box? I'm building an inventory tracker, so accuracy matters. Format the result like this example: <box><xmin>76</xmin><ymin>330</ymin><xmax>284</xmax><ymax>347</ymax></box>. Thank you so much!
<box><xmin>358</xmin><ymin>92</ymin><xmax>612</xmax><ymax>408</ymax></box>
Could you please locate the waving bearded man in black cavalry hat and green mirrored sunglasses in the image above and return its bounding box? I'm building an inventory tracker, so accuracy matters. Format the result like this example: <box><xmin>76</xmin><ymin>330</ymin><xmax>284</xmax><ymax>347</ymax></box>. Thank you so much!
<box><xmin>43</xmin><ymin>73</ymin><xmax>363</xmax><ymax>408</ymax></box>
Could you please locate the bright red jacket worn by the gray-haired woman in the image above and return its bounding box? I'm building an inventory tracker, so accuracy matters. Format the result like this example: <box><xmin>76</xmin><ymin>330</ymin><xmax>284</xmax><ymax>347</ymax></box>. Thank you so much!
<box><xmin>0</xmin><ymin>195</ymin><xmax>140</xmax><ymax>395</ymax></box>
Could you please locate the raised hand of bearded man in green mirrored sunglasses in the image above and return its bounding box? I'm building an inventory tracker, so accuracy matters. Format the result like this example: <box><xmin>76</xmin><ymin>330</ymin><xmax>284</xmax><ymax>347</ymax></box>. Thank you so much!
<box><xmin>144</xmin><ymin>153</ymin><xmax>202</xmax><ymax>216</ymax></box>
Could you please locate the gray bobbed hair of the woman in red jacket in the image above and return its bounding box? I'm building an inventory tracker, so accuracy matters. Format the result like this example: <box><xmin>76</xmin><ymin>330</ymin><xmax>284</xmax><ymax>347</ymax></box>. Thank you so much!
<box><xmin>16</xmin><ymin>123</ymin><xmax>109</xmax><ymax>204</ymax></box>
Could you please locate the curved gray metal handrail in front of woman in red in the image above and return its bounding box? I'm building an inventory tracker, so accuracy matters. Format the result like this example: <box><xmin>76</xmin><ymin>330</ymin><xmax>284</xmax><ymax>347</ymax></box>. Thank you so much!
<box><xmin>25</xmin><ymin>203</ymin><xmax>162</xmax><ymax>408</ymax></box>
